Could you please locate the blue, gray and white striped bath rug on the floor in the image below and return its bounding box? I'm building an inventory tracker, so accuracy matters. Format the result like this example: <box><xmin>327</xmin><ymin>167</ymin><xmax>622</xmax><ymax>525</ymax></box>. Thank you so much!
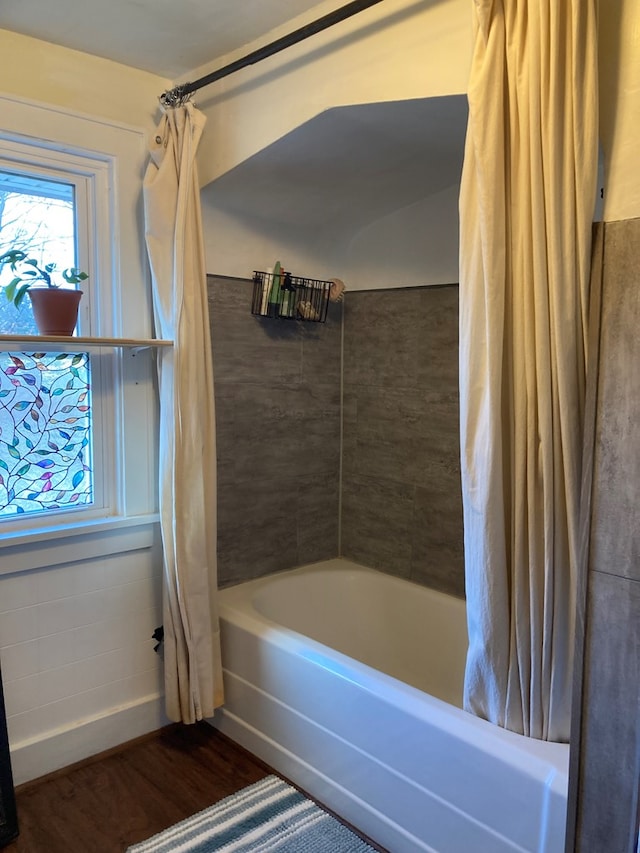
<box><xmin>127</xmin><ymin>776</ymin><xmax>374</xmax><ymax>853</ymax></box>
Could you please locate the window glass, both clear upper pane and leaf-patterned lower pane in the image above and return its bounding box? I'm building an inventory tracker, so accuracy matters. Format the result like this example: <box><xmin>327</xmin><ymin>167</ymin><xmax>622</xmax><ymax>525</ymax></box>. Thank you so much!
<box><xmin>0</xmin><ymin>170</ymin><xmax>99</xmax><ymax>521</ymax></box>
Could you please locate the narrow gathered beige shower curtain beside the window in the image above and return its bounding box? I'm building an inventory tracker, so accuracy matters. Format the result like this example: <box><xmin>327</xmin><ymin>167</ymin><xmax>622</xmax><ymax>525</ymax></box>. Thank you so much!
<box><xmin>144</xmin><ymin>103</ymin><xmax>223</xmax><ymax>723</ymax></box>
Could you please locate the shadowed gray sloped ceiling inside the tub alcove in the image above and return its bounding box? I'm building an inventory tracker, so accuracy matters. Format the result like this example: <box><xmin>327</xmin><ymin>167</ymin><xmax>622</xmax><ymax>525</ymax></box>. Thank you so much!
<box><xmin>203</xmin><ymin>96</ymin><xmax>467</xmax><ymax>241</ymax></box>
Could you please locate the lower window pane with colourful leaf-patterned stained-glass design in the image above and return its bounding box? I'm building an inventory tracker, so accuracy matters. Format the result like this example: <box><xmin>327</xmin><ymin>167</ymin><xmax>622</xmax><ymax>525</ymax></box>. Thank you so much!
<box><xmin>0</xmin><ymin>352</ymin><xmax>94</xmax><ymax>519</ymax></box>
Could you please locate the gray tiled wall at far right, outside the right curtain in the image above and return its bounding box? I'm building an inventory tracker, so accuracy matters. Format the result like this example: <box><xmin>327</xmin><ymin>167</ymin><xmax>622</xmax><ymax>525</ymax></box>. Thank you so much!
<box><xmin>567</xmin><ymin>218</ymin><xmax>640</xmax><ymax>853</ymax></box>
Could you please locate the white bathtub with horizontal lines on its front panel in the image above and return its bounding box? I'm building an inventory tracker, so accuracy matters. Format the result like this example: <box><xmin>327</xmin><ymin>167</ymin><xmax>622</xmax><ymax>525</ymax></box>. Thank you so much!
<box><xmin>212</xmin><ymin>559</ymin><xmax>568</xmax><ymax>853</ymax></box>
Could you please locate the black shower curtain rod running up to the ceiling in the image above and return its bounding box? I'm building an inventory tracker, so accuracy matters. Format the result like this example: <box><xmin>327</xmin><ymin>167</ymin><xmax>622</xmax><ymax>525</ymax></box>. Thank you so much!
<box><xmin>160</xmin><ymin>0</ymin><xmax>390</xmax><ymax>107</ymax></box>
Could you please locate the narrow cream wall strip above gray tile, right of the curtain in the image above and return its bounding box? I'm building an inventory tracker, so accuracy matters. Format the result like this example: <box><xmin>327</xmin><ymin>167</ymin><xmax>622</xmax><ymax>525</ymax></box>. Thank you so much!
<box><xmin>599</xmin><ymin>0</ymin><xmax>640</xmax><ymax>222</ymax></box>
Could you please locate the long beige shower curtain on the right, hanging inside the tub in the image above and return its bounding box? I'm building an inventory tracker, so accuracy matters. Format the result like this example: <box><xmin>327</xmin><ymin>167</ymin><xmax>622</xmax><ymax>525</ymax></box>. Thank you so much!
<box><xmin>460</xmin><ymin>0</ymin><xmax>598</xmax><ymax>741</ymax></box>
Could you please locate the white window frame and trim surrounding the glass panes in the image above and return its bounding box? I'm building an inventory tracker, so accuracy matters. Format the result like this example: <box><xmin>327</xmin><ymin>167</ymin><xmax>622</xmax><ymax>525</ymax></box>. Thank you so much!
<box><xmin>0</xmin><ymin>96</ymin><xmax>158</xmax><ymax>574</ymax></box>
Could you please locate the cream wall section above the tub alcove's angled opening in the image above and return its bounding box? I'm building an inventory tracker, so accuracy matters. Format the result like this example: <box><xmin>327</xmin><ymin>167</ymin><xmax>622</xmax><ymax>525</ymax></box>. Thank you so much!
<box><xmin>188</xmin><ymin>0</ymin><xmax>472</xmax><ymax>186</ymax></box>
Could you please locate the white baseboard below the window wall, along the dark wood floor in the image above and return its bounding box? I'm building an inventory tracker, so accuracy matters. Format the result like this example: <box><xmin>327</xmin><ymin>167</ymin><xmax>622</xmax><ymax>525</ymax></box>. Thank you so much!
<box><xmin>11</xmin><ymin>696</ymin><xmax>170</xmax><ymax>785</ymax></box>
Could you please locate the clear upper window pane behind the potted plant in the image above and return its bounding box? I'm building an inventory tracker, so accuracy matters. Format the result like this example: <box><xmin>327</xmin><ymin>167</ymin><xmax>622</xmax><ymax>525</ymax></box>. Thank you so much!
<box><xmin>0</xmin><ymin>171</ymin><xmax>76</xmax><ymax>335</ymax></box>
